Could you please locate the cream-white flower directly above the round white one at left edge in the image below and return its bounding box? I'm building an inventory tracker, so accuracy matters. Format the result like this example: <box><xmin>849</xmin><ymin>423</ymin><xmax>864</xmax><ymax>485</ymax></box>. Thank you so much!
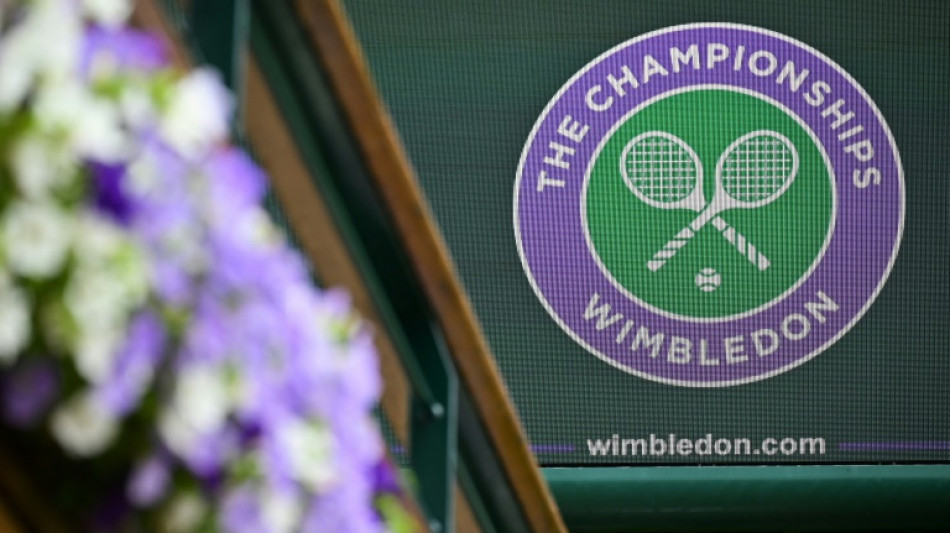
<box><xmin>10</xmin><ymin>135</ymin><xmax>76</xmax><ymax>199</ymax></box>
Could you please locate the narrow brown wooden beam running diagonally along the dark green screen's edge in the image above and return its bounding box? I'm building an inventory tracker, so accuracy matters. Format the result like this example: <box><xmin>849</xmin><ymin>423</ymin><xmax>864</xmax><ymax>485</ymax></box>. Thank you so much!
<box><xmin>295</xmin><ymin>0</ymin><xmax>566</xmax><ymax>533</ymax></box>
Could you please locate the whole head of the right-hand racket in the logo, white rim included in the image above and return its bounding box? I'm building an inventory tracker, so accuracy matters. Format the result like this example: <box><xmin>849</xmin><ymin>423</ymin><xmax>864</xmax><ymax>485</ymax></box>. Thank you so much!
<box><xmin>716</xmin><ymin>130</ymin><xmax>799</xmax><ymax>207</ymax></box>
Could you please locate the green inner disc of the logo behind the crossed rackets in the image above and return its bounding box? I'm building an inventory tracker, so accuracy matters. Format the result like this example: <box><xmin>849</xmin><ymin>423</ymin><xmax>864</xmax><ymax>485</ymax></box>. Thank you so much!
<box><xmin>584</xmin><ymin>89</ymin><xmax>834</xmax><ymax>319</ymax></box>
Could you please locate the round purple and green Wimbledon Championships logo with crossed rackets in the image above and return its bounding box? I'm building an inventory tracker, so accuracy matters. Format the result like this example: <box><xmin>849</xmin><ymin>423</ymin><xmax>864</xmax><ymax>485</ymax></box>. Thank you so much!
<box><xmin>514</xmin><ymin>24</ymin><xmax>904</xmax><ymax>387</ymax></box>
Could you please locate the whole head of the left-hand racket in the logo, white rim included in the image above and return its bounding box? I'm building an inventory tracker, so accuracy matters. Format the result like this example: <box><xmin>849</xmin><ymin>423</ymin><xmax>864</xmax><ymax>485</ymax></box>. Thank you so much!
<box><xmin>620</xmin><ymin>131</ymin><xmax>704</xmax><ymax>210</ymax></box>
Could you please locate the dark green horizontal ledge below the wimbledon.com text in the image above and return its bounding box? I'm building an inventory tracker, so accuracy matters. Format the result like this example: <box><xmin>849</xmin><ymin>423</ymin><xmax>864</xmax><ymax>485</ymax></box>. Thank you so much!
<box><xmin>545</xmin><ymin>465</ymin><xmax>950</xmax><ymax>533</ymax></box>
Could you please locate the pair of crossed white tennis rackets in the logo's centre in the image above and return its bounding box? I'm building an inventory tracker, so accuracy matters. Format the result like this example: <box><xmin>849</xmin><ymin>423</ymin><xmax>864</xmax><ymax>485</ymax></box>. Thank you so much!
<box><xmin>620</xmin><ymin>130</ymin><xmax>798</xmax><ymax>272</ymax></box>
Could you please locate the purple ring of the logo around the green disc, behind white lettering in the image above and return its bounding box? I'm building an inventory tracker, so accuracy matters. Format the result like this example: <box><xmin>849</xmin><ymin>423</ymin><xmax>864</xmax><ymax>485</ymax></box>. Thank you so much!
<box><xmin>515</xmin><ymin>23</ymin><xmax>904</xmax><ymax>386</ymax></box>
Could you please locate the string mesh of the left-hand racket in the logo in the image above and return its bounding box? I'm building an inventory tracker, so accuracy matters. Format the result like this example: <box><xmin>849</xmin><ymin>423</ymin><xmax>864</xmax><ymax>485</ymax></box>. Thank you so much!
<box><xmin>625</xmin><ymin>137</ymin><xmax>698</xmax><ymax>203</ymax></box>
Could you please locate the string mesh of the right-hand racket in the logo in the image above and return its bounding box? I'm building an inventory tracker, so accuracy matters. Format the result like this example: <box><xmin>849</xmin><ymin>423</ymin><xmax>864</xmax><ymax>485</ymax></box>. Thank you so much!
<box><xmin>722</xmin><ymin>135</ymin><xmax>795</xmax><ymax>202</ymax></box>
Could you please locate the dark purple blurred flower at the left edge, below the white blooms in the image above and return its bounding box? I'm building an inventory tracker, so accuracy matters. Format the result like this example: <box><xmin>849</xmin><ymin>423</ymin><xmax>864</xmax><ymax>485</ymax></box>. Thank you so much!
<box><xmin>2</xmin><ymin>358</ymin><xmax>59</xmax><ymax>427</ymax></box>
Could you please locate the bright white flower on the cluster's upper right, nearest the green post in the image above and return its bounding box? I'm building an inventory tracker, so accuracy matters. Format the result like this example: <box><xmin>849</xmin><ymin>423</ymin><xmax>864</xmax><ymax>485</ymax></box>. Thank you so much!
<box><xmin>160</xmin><ymin>69</ymin><xmax>232</xmax><ymax>159</ymax></box>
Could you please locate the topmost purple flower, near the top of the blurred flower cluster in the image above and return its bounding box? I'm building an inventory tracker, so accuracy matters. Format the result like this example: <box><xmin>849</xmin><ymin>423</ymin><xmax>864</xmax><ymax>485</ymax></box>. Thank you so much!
<box><xmin>80</xmin><ymin>27</ymin><xmax>168</xmax><ymax>76</ymax></box>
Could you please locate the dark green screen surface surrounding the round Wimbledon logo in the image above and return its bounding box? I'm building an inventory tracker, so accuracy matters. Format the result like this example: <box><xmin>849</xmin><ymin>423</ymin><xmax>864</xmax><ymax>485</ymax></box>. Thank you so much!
<box><xmin>344</xmin><ymin>0</ymin><xmax>950</xmax><ymax>464</ymax></box>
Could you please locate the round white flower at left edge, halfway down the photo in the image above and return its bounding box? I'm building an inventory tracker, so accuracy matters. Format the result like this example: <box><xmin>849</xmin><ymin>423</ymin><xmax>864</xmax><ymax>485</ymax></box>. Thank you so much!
<box><xmin>2</xmin><ymin>201</ymin><xmax>70</xmax><ymax>278</ymax></box>
